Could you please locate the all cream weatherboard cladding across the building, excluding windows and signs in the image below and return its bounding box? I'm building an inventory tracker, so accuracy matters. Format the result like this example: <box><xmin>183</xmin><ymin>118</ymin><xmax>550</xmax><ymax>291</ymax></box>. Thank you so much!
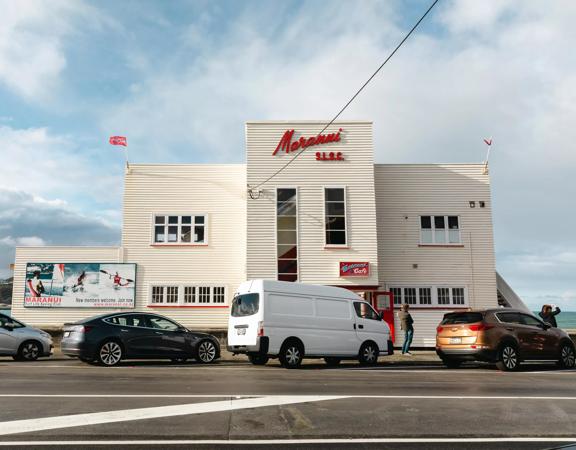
<box><xmin>13</xmin><ymin>122</ymin><xmax>497</xmax><ymax>346</ymax></box>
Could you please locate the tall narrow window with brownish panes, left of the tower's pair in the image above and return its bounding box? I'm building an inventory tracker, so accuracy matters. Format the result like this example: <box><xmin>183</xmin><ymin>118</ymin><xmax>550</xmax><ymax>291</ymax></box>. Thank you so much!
<box><xmin>276</xmin><ymin>188</ymin><xmax>298</xmax><ymax>281</ymax></box>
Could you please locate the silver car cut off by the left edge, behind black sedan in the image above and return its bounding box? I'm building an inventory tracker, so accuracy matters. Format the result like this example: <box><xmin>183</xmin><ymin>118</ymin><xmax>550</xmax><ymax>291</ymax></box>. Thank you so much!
<box><xmin>0</xmin><ymin>314</ymin><xmax>53</xmax><ymax>361</ymax></box>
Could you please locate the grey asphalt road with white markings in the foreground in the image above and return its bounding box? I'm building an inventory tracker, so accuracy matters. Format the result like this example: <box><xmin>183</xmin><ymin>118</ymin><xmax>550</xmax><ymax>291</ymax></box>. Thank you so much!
<box><xmin>0</xmin><ymin>358</ymin><xmax>576</xmax><ymax>450</ymax></box>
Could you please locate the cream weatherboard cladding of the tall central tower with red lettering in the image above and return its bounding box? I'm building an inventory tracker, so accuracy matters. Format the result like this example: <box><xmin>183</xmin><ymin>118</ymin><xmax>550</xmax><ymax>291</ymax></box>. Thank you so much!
<box><xmin>246</xmin><ymin>121</ymin><xmax>378</xmax><ymax>286</ymax></box>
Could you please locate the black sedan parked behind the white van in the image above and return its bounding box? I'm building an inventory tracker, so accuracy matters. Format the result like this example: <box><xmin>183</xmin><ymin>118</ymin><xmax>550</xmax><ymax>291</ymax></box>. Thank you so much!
<box><xmin>61</xmin><ymin>312</ymin><xmax>220</xmax><ymax>366</ymax></box>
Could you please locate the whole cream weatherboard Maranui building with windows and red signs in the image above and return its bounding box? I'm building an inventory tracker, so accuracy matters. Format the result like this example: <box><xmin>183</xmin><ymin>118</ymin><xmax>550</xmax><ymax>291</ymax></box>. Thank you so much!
<box><xmin>12</xmin><ymin>121</ymin><xmax>522</xmax><ymax>347</ymax></box>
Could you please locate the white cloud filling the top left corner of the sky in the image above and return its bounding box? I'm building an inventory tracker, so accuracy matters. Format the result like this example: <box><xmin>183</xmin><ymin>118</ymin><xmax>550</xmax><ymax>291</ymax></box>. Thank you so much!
<box><xmin>0</xmin><ymin>0</ymin><xmax>102</xmax><ymax>102</ymax></box>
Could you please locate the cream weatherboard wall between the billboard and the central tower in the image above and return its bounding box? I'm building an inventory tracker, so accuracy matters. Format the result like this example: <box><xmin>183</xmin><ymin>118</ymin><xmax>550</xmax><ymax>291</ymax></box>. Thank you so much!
<box><xmin>122</xmin><ymin>164</ymin><xmax>246</xmax><ymax>329</ymax></box>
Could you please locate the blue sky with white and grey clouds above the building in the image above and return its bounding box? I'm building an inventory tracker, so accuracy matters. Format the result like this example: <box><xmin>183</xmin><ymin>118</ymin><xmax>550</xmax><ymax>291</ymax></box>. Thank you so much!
<box><xmin>0</xmin><ymin>0</ymin><xmax>576</xmax><ymax>310</ymax></box>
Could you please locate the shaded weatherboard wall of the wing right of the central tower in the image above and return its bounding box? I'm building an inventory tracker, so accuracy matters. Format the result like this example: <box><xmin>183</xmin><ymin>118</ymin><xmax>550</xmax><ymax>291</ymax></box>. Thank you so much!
<box><xmin>374</xmin><ymin>164</ymin><xmax>498</xmax><ymax>346</ymax></box>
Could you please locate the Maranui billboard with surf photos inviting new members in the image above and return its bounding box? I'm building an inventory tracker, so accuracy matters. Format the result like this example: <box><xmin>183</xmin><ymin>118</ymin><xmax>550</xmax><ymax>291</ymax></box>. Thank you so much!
<box><xmin>24</xmin><ymin>263</ymin><xmax>136</xmax><ymax>308</ymax></box>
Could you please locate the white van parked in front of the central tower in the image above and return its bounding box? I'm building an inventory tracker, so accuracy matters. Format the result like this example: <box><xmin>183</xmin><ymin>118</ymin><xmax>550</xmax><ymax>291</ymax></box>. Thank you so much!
<box><xmin>227</xmin><ymin>280</ymin><xmax>394</xmax><ymax>368</ymax></box>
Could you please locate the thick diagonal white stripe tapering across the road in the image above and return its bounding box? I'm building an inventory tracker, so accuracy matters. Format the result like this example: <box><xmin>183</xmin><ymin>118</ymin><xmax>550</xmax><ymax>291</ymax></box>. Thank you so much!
<box><xmin>0</xmin><ymin>395</ymin><xmax>346</xmax><ymax>436</ymax></box>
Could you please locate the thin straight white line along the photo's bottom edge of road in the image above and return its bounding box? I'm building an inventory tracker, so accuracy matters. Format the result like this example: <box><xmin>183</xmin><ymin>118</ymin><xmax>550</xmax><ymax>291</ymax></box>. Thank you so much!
<box><xmin>0</xmin><ymin>436</ymin><xmax>576</xmax><ymax>447</ymax></box>
